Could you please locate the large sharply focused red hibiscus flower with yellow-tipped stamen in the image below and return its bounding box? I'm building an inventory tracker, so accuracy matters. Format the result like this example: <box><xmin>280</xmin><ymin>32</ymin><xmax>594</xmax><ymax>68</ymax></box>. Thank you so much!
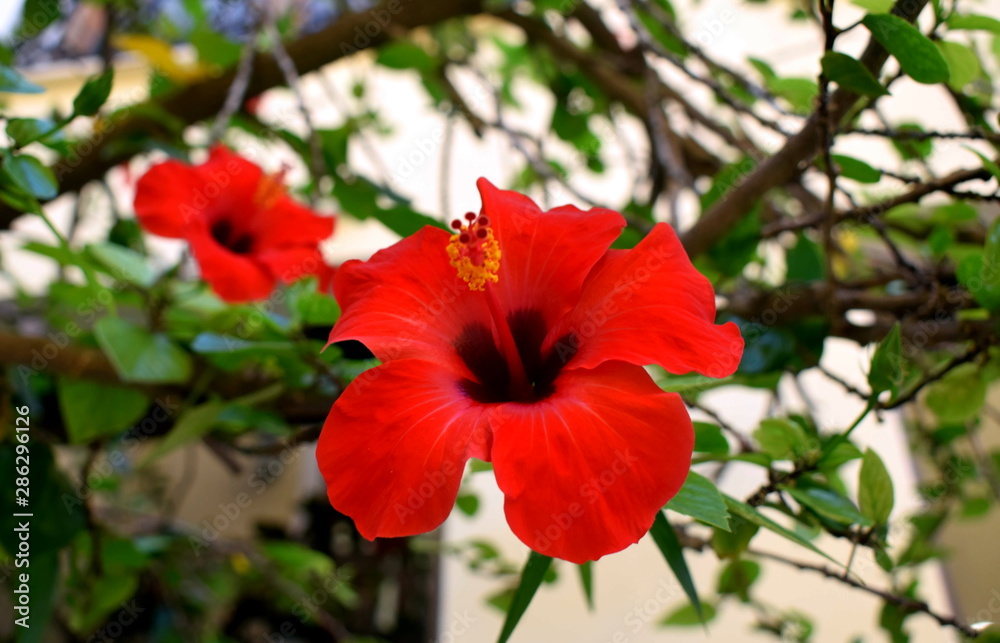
<box><xmin>317</xmin><ymin>179</ymin><xmax>743</xmax><ymax>563</ymax></box>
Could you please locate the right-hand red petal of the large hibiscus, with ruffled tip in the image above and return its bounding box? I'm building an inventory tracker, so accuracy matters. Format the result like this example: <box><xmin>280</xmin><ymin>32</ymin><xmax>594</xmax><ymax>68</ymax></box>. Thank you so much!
<box><xmin>549</xmin><ymin>223</ymin><xmax>743</xmax><ymax>377</ymax></box>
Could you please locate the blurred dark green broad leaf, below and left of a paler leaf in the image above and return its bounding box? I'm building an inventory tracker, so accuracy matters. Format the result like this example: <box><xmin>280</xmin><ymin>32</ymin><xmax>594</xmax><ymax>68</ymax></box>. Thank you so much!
<box><xmin>56</xmin><ymin>377</ymin><xmax>149</xmax><ymax>444</ymax></box>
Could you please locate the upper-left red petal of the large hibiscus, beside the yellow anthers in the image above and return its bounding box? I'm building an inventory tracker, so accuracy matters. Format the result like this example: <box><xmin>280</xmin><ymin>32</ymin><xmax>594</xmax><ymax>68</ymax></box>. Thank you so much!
<box><xmin>330</xmin><ymin>226</ymin><xmax>490</xmax><ymax>369</ymax></box>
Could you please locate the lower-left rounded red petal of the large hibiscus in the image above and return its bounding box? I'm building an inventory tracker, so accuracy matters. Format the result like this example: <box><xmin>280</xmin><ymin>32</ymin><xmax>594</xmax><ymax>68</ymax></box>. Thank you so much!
<box><xmin>316</xmin><ymin>360</ymin><xmax>490</xmax><ymax>540</ymax></box>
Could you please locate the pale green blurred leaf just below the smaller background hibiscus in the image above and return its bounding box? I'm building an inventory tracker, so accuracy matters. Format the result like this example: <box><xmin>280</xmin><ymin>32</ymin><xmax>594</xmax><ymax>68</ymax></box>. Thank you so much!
<box><xmin>94</xmin><ymin>317</ymin><xmax>192</xmax><ymax>384</ymax></box>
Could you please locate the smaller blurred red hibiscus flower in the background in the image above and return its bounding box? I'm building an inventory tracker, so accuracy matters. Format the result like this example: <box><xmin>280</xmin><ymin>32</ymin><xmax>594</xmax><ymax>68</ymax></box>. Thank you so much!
<box><xmin>135</xmin><ymin>146</ymin><xmax>334</xmax><ymax>302</ymax></box>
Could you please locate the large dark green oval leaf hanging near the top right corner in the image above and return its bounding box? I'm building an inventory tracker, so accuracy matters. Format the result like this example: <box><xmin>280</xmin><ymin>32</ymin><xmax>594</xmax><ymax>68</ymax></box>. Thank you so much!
<box><xmin>861</xmin><ymin>13</ymin><xmax>949</xmax><ymax>85</ymax></box>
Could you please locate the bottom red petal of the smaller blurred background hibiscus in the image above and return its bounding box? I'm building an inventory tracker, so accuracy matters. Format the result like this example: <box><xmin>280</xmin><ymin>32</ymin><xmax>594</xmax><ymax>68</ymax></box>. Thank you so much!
<box><xmin>189</xmin><ymin>230</ymin><xmax>275</xmax><ymax>302</ymax></box>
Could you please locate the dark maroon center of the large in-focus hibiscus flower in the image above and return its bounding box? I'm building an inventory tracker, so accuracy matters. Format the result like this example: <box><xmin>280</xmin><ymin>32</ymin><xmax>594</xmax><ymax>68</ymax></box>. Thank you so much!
<box><xmin>453</xmin><ymin>309</ymin><xmax>577</xmax><ymax>404</ymax></box>
